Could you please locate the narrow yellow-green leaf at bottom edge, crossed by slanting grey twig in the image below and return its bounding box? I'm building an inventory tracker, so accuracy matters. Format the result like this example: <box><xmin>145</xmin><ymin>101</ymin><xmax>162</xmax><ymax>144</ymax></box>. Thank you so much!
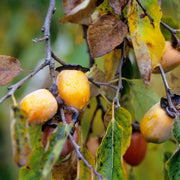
<box><xmin>79</xmin><ymin>146</ymin><xmax>95</xmax><ymax>180</ymax></box>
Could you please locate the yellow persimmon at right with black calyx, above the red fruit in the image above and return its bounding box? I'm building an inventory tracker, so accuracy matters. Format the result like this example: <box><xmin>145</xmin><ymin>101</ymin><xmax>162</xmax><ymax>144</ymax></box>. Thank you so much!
<box><xmin>140</xmin><ymin>103</ymin><xmax>174</xmax><ymax>143</ymax></box>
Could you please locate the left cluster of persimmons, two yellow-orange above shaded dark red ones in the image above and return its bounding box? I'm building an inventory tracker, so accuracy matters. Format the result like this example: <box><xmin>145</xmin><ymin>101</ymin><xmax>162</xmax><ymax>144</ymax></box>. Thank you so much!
<box><xmin>20</xmin><ymin>70</ymin><xmax>90</xmax><ymax>158</ymax></box>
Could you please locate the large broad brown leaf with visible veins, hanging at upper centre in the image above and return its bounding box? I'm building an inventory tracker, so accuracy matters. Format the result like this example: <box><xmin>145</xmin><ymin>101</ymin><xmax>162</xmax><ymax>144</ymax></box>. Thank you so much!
<box><xmin>87</xmin><ymin>14</ymin><xmax>127</xmax><ymax>57</ymax></box>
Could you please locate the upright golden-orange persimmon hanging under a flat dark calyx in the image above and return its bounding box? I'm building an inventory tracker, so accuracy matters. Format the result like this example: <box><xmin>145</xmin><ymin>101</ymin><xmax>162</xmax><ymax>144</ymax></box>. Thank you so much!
<box><xmin>56</xmin><ymin>70</ymin><xmax>90</xmax><ymax>110</ymax></box>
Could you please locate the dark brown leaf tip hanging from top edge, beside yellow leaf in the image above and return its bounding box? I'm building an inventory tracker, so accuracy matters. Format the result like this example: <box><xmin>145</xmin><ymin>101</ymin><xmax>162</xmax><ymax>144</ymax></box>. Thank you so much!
<box><xmin>108</xmin><ymin>0</ymin><xmax>128</xmax><ymax>15</ymax></box>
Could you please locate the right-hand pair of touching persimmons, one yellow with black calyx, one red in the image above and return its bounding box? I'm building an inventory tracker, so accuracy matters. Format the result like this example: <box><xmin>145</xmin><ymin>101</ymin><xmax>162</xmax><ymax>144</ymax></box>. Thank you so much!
<box><xmin>124</xmin><ymin>94</ymin><xmax>180</xmax><ymax>166</ymax></box>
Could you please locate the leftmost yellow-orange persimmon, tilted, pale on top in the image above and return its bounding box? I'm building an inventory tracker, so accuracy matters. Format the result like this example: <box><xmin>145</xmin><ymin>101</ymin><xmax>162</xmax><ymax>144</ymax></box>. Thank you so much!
<box><xmin>20</xmin><ymin>89</ymin><xmax>58</xmax><ymax>126</ymax></box>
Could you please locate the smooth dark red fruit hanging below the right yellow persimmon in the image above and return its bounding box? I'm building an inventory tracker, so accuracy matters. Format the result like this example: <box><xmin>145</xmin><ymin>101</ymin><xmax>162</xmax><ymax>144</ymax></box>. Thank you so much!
<box><xmin>124</xmin><ymin>131</ymin><xmax>147</xmax><ymax>166</ymax></box>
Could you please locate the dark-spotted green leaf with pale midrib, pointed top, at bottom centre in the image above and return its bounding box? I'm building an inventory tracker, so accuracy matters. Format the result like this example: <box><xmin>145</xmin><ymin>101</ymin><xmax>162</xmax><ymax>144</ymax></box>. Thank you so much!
<box><xmin>97</xmin><ymin>110</ymin><xmax>125</xmax><ymax>180</ymax></box>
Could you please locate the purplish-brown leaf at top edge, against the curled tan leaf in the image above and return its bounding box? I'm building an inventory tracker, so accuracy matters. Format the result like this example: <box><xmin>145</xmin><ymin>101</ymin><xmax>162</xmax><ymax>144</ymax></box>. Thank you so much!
<box><xmin>63</xmin><ymin>0</ymin><xmax>82</xmax><ymax>14</ymax></box>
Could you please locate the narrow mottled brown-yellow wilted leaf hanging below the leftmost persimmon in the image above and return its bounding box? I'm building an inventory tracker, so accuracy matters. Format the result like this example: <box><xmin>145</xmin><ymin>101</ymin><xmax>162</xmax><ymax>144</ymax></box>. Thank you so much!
<box><xmin>11</xmin><ymin>106</ymin><xmax>31</xmax><ymax>167</ymax></box>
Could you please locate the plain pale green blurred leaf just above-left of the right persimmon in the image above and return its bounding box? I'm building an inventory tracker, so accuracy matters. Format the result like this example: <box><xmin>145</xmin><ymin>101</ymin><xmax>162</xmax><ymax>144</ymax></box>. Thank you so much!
<box><xmin>127</xmin><ymin>79</ymin><xmax>160</xmax><ymax>121</ymax></box>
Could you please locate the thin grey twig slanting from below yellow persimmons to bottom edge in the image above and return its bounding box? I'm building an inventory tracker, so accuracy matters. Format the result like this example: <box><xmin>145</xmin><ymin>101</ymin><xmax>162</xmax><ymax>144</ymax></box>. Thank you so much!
<box><xmin>60</xmin><ymin>107</ymin><xmax>103</xmax><ymax>180</ymax></box>
